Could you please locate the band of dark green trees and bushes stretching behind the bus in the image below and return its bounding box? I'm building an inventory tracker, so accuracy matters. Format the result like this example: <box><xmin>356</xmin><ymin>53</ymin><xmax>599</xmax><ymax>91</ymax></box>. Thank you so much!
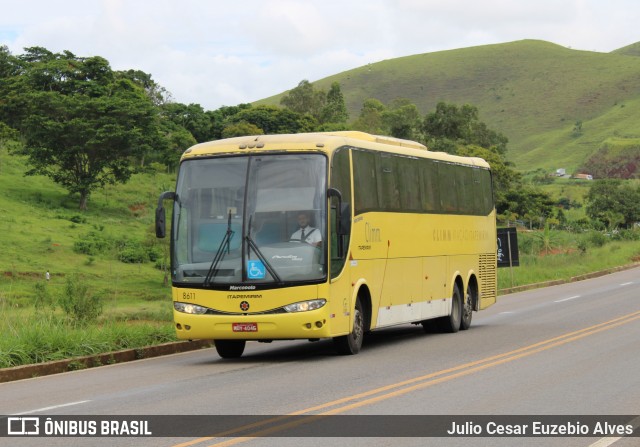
<box><xmin>0</xmin><ymin>47</ymin><xmax>550</xmax><ymax>226</ymax></box>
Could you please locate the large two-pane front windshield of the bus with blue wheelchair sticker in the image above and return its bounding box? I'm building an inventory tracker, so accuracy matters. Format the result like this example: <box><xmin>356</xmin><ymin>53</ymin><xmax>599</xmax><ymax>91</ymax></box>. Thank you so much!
<box><xmin>172</xmin><ymin>154</ymin><xmax>327</xmax><ymax>290</ymax></box>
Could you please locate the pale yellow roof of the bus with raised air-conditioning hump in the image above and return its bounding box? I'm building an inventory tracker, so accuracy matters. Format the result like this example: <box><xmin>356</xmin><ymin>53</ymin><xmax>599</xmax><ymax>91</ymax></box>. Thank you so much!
<box><xmin>182</xmin><ymin>131</ymin><xmax>489</xmax><ymax>168</ymax></box>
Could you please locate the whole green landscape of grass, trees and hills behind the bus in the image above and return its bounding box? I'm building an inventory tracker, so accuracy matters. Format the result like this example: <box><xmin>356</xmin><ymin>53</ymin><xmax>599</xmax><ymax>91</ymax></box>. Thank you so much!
<box><xmin>0</xmin><ymin>41</ymin><xmax>640</xmax><ymax>367</ymax></box>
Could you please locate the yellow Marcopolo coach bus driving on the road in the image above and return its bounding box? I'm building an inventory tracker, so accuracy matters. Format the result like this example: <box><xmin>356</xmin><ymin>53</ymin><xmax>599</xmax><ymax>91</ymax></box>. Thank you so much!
<box><xmin>156</xmin><ymin>132</ymin><xmax>496</xmax><ymax>358</ymax></box>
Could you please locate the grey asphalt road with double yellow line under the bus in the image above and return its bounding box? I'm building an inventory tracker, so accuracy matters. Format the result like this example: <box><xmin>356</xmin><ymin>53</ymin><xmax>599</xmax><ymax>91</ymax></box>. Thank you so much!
<box><xmin>0</xmin><ymin>268</ymin><xmax>640</xmax><ymax>447</ymax></box>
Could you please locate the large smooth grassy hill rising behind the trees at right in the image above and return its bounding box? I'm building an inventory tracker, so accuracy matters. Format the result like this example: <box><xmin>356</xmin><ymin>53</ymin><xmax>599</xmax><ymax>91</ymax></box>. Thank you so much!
<box><xmin>260</xmin><ymin>40</ymin><xmax>640</xmax><ymax>172</ymax></box>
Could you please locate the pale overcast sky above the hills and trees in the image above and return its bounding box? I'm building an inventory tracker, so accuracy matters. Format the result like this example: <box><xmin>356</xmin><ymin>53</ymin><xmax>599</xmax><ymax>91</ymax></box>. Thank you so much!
<box><xmin>0</xmin><ymin>0</ymin><xmax>640</xmax><ymax>110</ymax></box>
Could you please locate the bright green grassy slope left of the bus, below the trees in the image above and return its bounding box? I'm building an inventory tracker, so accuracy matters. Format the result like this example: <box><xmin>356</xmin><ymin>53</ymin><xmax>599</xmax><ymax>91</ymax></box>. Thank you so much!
<box><xmin>0</xmin><ymin>144</ymin><xmax>173</xmax><ymax>317</ymax></box>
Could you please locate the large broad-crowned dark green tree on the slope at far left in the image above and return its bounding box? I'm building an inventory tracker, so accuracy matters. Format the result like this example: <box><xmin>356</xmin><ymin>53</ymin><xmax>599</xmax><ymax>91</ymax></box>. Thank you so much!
<box><xmin>0</xmin><ymin>47</ymin><xmax>162</xmax><ymax>210</ymax></box>
